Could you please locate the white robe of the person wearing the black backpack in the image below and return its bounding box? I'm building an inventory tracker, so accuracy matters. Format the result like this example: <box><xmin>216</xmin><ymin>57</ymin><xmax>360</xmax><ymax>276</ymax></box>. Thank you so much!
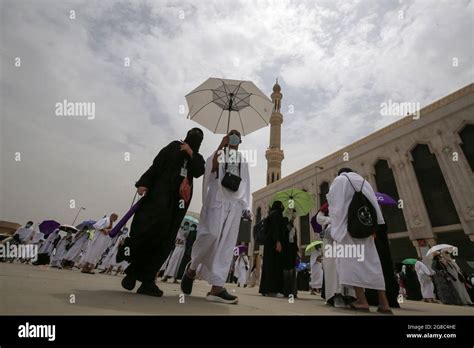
<box><xmin>326</xmin><ymin>173</ymin><xmax>385</xmax><ymax>290</ymax></box>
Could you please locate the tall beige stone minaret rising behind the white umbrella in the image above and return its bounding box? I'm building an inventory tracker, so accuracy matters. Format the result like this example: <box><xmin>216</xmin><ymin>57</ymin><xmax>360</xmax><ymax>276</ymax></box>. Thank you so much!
<box><xmin>265</xmin><ymin>79</ymin><xmax>285</xmax><ymax>185</ymax></box>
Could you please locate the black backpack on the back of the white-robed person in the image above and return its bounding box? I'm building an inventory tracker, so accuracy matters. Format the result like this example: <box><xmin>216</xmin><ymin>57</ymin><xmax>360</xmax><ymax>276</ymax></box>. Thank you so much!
<box><xmin>344</xmin><ymin>174</ymin><xmax>377</xmax><ymax>239</ymax></box>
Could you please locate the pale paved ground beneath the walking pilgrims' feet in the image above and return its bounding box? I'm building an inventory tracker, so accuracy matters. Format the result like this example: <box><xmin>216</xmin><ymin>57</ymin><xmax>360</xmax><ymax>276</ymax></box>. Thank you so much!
<box><xmin>0</xmin><ymin>263</ymin><xmax>474</xmax><ymax>315</ymax></box>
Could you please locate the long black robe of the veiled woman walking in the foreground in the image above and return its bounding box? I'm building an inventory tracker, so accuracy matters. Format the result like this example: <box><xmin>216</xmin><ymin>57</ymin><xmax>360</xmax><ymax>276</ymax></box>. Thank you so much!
<box><xmin>124</xmin><ymin>141</ymin><xmax>205</xmax><ymax>282</ymax></box>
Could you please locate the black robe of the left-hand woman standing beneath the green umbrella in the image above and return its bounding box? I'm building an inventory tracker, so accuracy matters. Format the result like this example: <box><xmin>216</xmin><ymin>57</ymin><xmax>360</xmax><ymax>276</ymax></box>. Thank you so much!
<box><xmin>258</xmin><ymin>210</ymin><xmax>287</xmax><ymax>295</ymax></box>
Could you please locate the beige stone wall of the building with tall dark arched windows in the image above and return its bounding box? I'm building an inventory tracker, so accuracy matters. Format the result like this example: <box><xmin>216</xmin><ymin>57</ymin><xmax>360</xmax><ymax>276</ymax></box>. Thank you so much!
<box><xmin>253</xmin><ymin>84</ymin><xmax>474</xmax><ymax>258</ymax></box>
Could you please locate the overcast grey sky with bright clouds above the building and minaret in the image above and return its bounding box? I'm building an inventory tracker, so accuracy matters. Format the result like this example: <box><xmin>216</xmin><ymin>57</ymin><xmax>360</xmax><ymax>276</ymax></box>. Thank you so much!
<box><xmin>0</xmin><ymin>0</ymin><xmax>474</xmax><ymax>223</ymax></box>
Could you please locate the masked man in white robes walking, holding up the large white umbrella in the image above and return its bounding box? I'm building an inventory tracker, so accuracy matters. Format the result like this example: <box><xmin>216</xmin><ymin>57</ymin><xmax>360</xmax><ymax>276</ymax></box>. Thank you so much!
<box><xmin>181</xmin><ymin>130</ymin><xmax>250</xmax><ymax>304</ymax></box>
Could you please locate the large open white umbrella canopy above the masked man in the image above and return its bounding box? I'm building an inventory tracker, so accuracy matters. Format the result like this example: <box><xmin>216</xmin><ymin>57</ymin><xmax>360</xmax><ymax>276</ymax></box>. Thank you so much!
<box><xmin>186</xmin><ymin>77</ymin><xmax>273</xmax><ymax>135</ymax></box>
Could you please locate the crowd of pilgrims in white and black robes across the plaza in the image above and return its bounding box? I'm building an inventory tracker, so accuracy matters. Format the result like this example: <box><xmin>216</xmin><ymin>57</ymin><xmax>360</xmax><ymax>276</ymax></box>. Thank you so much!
<box><xmin>1</xmin><ymin>128</ymin><xmax>473</xmax><ymax>314</ymax></box>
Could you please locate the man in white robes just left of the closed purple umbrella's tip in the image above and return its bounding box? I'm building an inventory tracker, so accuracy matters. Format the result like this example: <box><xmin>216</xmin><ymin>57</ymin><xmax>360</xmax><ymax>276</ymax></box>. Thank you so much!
<box><xmin>81</xmin><ymin>214</ymin><xmax>117</xmax><ymax>274</ymax></box>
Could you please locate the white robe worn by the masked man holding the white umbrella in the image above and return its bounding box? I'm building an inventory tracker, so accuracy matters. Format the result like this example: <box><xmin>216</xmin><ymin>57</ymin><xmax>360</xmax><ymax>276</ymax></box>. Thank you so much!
<box><xmin>191</xmin><ymin>153</ymin><xmax>250</xmax><ymax>286</ymax></box>
